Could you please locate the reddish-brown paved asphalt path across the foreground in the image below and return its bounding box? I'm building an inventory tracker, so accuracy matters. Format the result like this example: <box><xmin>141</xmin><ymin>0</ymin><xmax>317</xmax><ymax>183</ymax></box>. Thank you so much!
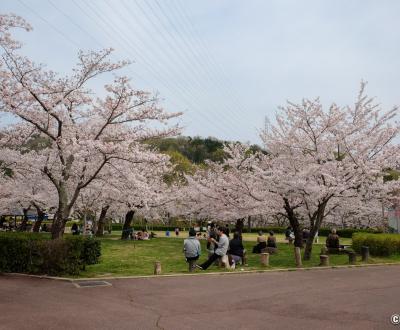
<box><xmin>0</xmin><ymin>266</ymin><xmax>400</xmax><ymax>330</ymax></box>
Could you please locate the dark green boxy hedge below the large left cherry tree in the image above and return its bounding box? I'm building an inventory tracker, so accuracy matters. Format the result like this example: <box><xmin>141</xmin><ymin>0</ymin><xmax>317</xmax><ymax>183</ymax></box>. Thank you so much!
<box><xmin>0</xmin><ymin>233</ymin><xmax>101</xmax><ymax>275</ymax></box>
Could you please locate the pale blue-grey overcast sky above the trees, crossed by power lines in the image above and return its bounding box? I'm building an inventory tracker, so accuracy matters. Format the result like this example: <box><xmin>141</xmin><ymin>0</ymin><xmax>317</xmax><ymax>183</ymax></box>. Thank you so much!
<box><xmin>0</xmin><ymin>0</ymin><xmax>400</xmax><ymax>143</ymax></box>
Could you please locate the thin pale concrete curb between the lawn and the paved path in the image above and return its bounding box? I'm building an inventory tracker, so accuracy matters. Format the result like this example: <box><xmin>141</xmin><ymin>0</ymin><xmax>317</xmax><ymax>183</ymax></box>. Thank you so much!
<box><xmin>0</xmin><ymin>262</ymin><xmax>400</xmax><ymax>283</ymax></box>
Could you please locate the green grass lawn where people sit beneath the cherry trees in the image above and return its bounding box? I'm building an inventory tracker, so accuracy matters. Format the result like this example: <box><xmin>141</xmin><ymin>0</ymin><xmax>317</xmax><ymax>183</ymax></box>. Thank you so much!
<box><xmin>80</xmin><ymin>233</ymin><xmax>400</xmax><ymax>277</ymax></box>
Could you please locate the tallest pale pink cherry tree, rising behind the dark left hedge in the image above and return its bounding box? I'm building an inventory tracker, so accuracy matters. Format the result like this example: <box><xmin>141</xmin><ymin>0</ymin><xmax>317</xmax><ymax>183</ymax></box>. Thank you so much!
<box><xmin>0</xmin><ymin>15</ymin><xmax>180</xmax><ymax>238</ymax></box>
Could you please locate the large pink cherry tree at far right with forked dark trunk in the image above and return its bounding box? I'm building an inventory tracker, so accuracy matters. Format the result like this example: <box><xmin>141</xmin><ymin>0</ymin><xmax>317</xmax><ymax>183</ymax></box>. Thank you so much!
<box><xmin>261</xmin><ymin>83</ymin><xmax>399</xmax><ymax>259</ymax></box>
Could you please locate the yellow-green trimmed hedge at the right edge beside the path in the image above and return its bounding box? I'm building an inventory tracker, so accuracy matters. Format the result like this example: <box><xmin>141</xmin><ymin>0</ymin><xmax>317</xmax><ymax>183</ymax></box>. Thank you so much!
<box><xmin>353</xmin><ymin>233</ymin><xmax>400</xmax><ymax>256</ymax></box>
